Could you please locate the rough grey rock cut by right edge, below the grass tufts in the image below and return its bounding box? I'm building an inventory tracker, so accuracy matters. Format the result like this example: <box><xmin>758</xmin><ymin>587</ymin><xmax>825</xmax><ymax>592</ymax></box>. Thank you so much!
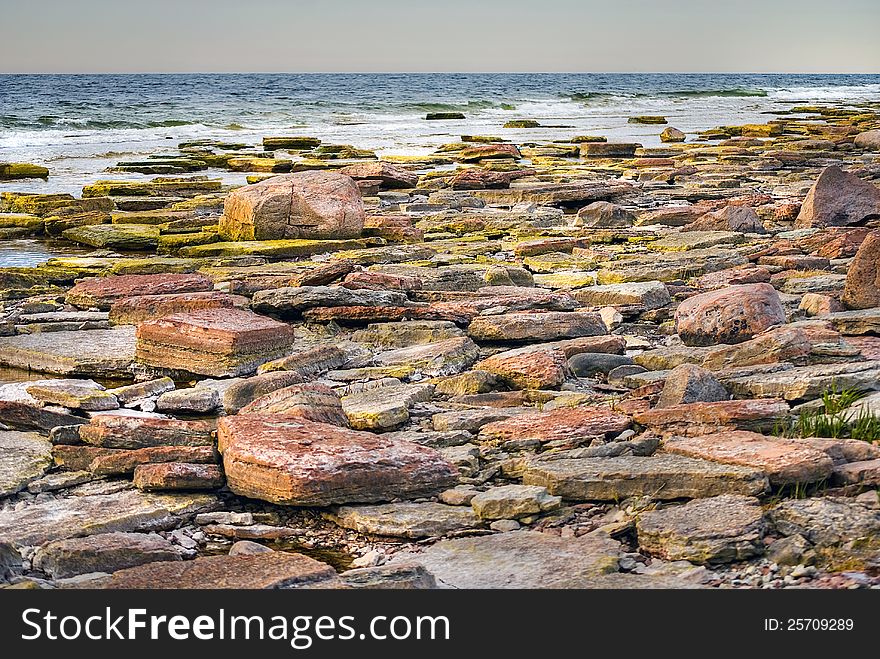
<box><xmin>769</xmin><ymin>497</ymin><xmax>880</xmax><ymax>547</ymax></box>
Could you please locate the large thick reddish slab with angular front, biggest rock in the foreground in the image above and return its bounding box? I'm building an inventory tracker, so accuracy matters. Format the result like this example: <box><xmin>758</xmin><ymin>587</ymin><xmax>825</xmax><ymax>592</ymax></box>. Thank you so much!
<box><xmin>218</xmin><ymin>415</ymin><xmax>458</xmax><ymax>506</ymax></box>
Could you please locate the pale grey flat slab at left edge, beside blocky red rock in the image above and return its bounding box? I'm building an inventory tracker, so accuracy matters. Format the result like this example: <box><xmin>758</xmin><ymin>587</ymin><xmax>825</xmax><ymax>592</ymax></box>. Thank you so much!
<box><xmin>0</xmin><ymin>327</ymin><xmax>135</xmax><ymax>378</ymax></box>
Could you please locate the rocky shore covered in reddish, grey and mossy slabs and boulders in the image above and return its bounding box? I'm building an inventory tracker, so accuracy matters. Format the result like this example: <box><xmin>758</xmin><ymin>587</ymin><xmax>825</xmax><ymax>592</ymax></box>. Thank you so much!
<box><xmin>0</xmin><ymin>104</ymin><xmax>880</xmax><ymax>588</ymax></box>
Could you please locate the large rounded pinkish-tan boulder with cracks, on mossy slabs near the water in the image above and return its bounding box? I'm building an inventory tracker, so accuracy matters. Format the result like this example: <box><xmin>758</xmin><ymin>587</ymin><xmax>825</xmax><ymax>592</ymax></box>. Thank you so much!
<box><xmin>220</xmin><ymin>171</ymin><xmax>364</xmax><ymax>240</ymax></box>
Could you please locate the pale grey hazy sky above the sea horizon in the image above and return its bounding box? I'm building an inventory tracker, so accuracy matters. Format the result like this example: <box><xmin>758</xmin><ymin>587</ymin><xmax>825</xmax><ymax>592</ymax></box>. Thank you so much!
<box><xmin>0</xmin><ymin>0</ymin><xmax>880</xmax><ymax>73</ymax></box>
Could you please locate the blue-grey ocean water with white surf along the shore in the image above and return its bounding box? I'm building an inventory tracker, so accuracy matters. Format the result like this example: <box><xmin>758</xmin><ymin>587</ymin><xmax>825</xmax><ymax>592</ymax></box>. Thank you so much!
<box><xmin>0</xmin><ymin>74</ymin><xmax>880</xmax><ymax>201</ymax></box>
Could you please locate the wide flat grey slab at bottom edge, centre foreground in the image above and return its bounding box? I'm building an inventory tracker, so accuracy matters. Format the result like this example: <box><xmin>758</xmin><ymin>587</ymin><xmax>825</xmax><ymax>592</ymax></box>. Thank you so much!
<box><xmin>390</xmin><ymin>531</ymin><xmax>620</xmax><ymax>588</ymax></box>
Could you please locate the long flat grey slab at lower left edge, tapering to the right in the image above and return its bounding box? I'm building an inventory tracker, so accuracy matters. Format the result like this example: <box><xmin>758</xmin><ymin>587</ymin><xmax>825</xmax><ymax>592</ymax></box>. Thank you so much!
<box><xmin>0</xmin><ymin>489</ymin><xmax>217</xmax><ymax>547</ymax></box>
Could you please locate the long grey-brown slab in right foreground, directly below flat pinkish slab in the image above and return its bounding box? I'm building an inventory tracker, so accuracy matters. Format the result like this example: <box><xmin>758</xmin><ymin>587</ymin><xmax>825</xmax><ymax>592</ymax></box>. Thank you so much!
<box><xmin>523</xmin><ymin>455</ymin><xmax>768</xmax><ymax>501</ymax></box>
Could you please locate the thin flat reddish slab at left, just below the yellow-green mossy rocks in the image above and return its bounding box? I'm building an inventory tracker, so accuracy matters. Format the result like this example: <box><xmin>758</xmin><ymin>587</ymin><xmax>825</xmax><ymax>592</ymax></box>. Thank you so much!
<box><xmin>66</xmin><ymin>274</ymin><xmax>214</xmax><ymax>310</ymax></box>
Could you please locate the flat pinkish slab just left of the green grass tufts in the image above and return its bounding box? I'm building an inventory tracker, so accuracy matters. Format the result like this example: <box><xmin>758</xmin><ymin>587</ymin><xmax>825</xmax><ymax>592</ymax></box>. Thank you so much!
<box><xmin>663</xmin><ymin>430</ymin><xmax>833</xmax><ymax>485</ymax></box>
